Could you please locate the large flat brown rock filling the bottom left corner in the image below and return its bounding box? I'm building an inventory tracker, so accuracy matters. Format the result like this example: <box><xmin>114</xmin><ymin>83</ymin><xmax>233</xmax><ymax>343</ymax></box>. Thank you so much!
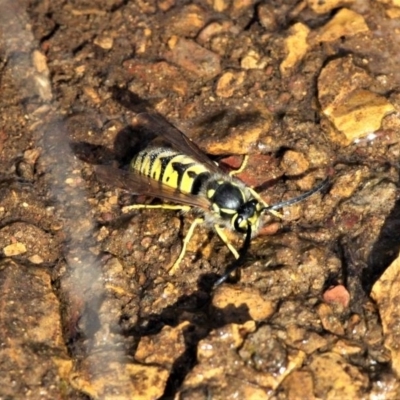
<box><xmin>0</xmin><ymin>261</ymin><xmax>68</xmax><ymax>399</ymax></box>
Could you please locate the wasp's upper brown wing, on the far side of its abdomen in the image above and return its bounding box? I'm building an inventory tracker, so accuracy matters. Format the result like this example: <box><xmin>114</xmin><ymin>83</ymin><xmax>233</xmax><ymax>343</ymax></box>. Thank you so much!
<box><xmin>136</xmin><ymin>112</ymin><xmax>221</xmax><ymax>173</ymax></box>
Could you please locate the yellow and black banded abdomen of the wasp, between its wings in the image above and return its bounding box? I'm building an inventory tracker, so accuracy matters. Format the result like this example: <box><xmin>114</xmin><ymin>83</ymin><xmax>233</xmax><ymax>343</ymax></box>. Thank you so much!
<box><xmin>131</xmin><ymin>147</ymin><xmax>211</xmax><ymax>195</ymax></box>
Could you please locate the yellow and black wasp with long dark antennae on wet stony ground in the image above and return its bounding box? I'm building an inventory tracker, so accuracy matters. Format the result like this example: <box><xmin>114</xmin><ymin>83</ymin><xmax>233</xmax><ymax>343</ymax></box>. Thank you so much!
<box><xmin>96</xmin><ymin>112</ymin><xmax>328</xmax><ymax>284</ymax></box>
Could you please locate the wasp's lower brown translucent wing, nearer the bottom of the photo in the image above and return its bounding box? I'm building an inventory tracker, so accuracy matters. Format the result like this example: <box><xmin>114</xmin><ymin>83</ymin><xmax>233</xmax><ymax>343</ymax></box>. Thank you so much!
<box><xmin>95</xmin><ymin>165</ymin><xmax>210</xmax><ymax>211</ymax></box>
